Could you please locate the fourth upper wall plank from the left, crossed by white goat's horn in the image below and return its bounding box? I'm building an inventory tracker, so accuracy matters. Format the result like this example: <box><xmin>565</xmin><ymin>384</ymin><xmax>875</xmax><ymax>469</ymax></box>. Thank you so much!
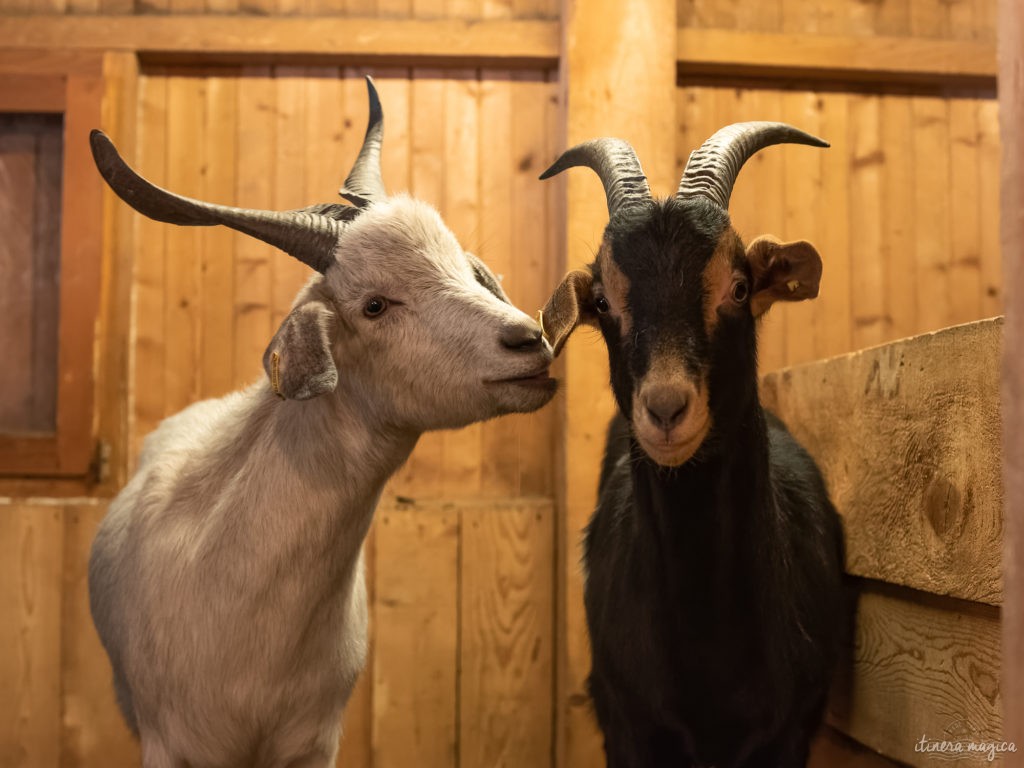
<box><xmin>232</xmin><ymin>67</ymin><xmax>278</xmax><ymax>386</ymax></box>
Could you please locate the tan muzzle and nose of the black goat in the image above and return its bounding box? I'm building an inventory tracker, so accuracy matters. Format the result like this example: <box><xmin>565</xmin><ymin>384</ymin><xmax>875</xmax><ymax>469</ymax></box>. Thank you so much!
<box><xmin>632</xmin><ymin>347</ymin><xmax>712</xmax><ymax>467</ymax></box>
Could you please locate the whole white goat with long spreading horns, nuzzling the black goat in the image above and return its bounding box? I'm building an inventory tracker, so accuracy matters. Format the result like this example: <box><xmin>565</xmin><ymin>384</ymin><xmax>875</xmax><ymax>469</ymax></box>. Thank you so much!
<box><xmin>89</xmin><ymin>83</ymin><xmax>555</xmax><ymax>768</ymax></box>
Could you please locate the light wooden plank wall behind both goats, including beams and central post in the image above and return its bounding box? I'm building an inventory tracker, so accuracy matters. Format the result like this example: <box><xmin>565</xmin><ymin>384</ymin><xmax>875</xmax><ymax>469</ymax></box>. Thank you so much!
<box><xmin>0</xmin><ymin>0</ymin><xmax>1002</xmax><ymax>768</ymax></box>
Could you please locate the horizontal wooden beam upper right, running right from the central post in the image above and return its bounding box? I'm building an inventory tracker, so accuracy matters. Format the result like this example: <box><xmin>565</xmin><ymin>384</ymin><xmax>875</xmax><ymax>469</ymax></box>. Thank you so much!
<box><xmin>678</xmin><ymin>29</ymin><xmax>996</xmax><ymax>86</ymax></box>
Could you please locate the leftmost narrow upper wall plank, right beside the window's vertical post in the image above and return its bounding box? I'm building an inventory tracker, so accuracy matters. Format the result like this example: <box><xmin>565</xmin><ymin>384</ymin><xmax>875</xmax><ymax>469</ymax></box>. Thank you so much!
<box><xmin>128</xmin><ymin>71</ymin><xmax>170</xmax><ymax>456</ymax></box>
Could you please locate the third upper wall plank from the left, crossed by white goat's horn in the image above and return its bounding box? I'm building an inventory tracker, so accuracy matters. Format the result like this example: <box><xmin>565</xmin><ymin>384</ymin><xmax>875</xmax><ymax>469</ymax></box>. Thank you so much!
<box><xmin>197</xmin><ymin>71</ymin><xmax>239</xmax><ymax>397</ymax></box>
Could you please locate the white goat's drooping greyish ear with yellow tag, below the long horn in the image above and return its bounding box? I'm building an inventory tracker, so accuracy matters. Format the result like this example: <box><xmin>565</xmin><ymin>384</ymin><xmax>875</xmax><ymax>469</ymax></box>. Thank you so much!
<box><xmin>263</xmin><ymin>299</ymin><xmax>338</xmax><ymax>400</ymax></box>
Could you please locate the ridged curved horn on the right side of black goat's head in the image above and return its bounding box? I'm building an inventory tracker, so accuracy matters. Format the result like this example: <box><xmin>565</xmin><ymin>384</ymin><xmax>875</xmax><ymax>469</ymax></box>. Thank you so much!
<box><xmin>676</xmin><ymin>121</ymin><xmax>828</xmax><ymax>210</ymax></box>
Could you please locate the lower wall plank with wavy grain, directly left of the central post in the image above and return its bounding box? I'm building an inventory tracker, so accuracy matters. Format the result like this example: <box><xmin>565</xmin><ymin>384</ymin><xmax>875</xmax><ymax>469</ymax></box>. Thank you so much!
<box><xmin>459</xmin><ymin>501</ymin><xmax>554</xmax><ymax>768</ymax></box>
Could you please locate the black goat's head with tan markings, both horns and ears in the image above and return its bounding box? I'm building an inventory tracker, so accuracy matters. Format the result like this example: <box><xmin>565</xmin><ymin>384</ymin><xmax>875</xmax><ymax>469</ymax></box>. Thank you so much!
<box><xmin>541</xmin><ymin>122</ymin><xmax>828</xmax><ymax>466</ymax></box>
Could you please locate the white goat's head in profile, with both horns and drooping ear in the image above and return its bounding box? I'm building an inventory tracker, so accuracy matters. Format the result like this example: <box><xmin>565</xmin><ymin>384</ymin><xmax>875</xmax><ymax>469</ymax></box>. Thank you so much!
<box><xmin>91</xmin><ymin>78</ymin><xmax>556</xmax><ymax>431</ymax></box>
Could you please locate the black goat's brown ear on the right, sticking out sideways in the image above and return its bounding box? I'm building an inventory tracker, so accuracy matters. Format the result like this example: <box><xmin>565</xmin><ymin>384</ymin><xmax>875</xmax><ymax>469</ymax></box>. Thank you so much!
<box><xmin>746</xmin><ymin>234</ymin><xmax>821</xmax><ymax>317</ymax></box>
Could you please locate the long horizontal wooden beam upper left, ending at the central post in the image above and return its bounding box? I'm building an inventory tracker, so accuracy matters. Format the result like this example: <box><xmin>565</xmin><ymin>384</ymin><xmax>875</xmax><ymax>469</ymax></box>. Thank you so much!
<box><xmin>0</xmin><ymin>15</ymin><xmax>559</xmax><ymax>68</ymax></box>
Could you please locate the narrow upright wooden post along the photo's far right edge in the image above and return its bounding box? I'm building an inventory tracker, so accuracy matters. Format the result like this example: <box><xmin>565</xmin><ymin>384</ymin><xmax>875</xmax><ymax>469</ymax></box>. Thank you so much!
<box><xmin>998</xmin><ymin>0</ymin><xmax>1024</xmax><ymax>768</ymax></box>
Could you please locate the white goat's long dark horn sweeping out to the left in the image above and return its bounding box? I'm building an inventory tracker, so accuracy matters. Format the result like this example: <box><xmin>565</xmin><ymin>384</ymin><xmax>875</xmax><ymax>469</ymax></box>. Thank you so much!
<box><xmin>89</xmin><ymin>130</ymin><xmax>344</xmax><ymax>272</ymax></box>
